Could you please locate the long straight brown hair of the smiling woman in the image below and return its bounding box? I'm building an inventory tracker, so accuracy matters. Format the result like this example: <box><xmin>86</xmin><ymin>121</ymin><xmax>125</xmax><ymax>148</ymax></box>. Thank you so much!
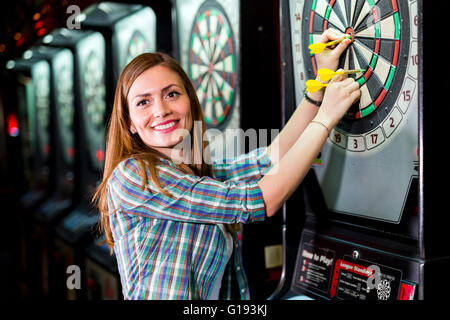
<box><xmin>92</xmin><ymin>52</ymin><xmax>212</xmax><ymax>254</ymax></box>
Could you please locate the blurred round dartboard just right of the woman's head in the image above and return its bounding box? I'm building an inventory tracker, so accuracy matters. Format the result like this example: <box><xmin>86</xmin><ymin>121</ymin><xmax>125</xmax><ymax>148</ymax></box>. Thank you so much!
<box><xmin>188</xmin><ymin>1</ymin><xmax>237</xmax><ymax>127</ymax></box>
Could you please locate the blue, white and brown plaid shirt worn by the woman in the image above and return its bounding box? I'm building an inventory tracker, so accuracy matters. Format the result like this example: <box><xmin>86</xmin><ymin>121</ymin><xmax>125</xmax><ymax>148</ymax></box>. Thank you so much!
<box><xmin>107</xmin><ymin>148</ymin><xmax>271</xmax><ymax>299</ymax></box>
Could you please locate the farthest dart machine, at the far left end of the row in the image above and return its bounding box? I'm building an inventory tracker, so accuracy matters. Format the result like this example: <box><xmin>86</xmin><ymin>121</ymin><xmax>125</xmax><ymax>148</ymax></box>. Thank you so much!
<box><xmin>5</xmin><ymin>53</ymin><xmax>54</xmax><ymax>297</ymax></box>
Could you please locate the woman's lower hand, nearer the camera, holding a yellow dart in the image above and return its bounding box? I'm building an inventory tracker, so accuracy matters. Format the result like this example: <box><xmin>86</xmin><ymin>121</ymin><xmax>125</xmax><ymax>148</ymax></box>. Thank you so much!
<box><xmin>314</xmin><ymin>69</ymin><xmax>361</xmax><ymax>130</ymax></box>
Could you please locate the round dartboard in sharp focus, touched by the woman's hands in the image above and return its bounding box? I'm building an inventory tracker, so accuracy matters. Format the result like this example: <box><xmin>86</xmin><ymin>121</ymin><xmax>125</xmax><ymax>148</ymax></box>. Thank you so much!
<box><xmin>296</xmin><ymin>0</ymin><xmax>411</xmax><ymax>152</ymax></box>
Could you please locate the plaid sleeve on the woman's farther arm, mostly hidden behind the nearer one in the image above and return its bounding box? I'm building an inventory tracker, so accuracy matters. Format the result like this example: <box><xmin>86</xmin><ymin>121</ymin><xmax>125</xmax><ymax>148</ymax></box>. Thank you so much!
<box><xmin>212</xmin><ymin>147</ymin><xmax>272</xmax><ymax>181</ymax></box>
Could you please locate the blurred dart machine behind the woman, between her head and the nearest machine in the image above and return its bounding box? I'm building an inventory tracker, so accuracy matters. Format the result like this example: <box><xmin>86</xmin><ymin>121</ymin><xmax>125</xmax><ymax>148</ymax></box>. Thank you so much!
<box><xmin>173</xmin><ymin>0</ymin><xmax>282</xmax><ymax>298</ymax></box>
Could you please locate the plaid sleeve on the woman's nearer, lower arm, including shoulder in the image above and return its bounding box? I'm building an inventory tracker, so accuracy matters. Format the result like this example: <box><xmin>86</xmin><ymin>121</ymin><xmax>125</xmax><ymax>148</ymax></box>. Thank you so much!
<box><xmin>108</xmin><ymin>158</ymin><xmax>265</xmax><ymax>223</ymax></box>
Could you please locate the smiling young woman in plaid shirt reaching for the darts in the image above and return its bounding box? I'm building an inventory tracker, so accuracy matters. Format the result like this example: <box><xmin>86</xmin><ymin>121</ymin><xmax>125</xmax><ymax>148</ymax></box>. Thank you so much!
<box><xmin>94</xmin><ymin>30</ymin><xmax>360</xmax><ymax>299</ymax></box>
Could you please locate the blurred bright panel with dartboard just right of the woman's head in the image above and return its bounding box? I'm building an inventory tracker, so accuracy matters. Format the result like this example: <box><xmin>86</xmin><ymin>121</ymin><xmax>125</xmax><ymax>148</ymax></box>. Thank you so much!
<box><xmin>176</xmin><ymin>0</ymin><xmax>240</xmax><ymax>130</ymax></box>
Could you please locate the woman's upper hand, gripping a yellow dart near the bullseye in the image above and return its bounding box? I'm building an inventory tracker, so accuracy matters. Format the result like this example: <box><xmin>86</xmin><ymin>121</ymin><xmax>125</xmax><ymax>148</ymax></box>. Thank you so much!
<box><xmin>316</xmin><ymin>29</ymin><xmax>352</xmax><ymax>71</ymax></box>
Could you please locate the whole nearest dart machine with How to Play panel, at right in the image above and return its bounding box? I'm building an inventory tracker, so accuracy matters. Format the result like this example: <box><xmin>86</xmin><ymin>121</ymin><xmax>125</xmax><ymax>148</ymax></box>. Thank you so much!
<box><xmin>271</xmin><ymin>0</ymin><xmax>449</xmax><ymax>300</ymax></box>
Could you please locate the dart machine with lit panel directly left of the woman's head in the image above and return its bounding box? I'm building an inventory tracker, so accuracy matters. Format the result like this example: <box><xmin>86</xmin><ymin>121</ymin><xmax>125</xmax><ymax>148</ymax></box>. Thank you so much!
<box><xmin>77</xmin><ymin>2</ymin><xmax>156</xmax><ymax>300</ymax></box>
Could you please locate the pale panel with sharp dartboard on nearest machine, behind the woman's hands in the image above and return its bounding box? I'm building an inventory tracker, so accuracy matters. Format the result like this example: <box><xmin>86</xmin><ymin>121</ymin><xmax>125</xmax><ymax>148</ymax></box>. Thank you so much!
<box><xmin>289</xmin><ymin>0</ymin><xmax>418</xmax><ymax>223</ymax></box>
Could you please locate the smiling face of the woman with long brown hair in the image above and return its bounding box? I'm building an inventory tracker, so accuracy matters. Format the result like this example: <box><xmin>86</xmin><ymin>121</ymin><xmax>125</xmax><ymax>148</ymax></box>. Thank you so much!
<box><xmin>127</xmin><ymin>66</ymin><xmax>192</xmax><ymax>154</ymax></box>
